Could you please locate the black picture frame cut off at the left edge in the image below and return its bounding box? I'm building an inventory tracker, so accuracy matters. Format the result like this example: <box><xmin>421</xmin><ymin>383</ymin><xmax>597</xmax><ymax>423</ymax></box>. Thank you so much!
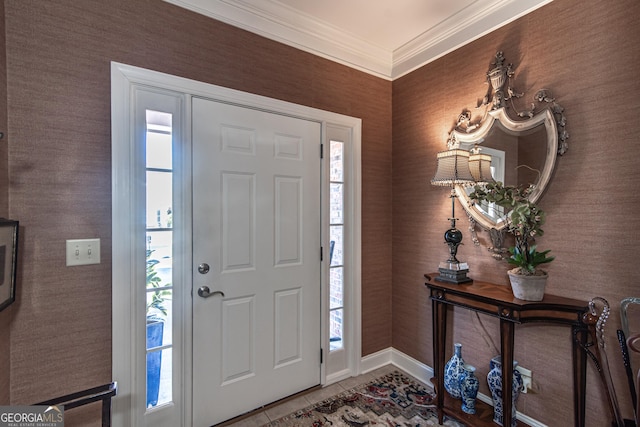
<box><xmin>0</xmin><ymin>218</ymin><xmax>18</xmax><ymax>311</ymax></box>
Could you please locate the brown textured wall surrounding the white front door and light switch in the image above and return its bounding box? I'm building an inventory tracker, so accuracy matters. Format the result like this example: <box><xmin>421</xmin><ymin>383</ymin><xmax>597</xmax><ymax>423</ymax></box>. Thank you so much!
<box><xmin>0</xmin><ymin>0</ymin><xmax>391</xmax><ymax>425</ymax></box>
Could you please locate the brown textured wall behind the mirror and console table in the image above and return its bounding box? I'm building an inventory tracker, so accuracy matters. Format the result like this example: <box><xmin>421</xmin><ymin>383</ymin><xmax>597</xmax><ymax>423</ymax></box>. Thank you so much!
<box><xmin>393</xmin><ymin>0</ymin><xmax>640</xmax><ymax>426</ymax></box>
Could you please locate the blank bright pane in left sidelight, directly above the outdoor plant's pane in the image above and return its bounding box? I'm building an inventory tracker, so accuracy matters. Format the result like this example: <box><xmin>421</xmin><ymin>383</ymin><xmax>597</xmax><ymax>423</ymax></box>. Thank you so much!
<box><xmin>147</xmin><ymin>171</ymin><xmax>173</xmax><ymax>228</ymax></box>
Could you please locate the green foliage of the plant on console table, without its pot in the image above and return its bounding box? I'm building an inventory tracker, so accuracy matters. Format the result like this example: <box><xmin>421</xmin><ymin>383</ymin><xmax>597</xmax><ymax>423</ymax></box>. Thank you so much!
<box><xmin>469</xmin><ymin>182</ymin><xmax>555</xmax><ymax>276</ymax></box>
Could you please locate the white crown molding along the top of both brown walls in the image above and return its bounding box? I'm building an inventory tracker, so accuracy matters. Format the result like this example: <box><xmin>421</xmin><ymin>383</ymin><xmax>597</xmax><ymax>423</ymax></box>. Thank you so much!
<box><xmin>164</xmin><ymin>0</ymin><xmax>553</xmax><ymax>80</ymax></box>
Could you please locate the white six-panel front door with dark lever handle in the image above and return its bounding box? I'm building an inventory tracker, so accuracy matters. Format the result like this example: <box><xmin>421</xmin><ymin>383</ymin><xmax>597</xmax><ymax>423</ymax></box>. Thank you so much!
<box><xmin>192</xmin><ymin>98</ymin><xmax>321</xmax><ymax>427</ymax></box>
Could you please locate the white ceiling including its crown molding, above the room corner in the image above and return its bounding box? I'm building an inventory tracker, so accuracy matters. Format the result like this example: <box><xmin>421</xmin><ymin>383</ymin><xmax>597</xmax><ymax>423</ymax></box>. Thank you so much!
<box><xmin>165</xmin><ymin>0</ymin><xmax>552</xmax><ymax>80</ymax></box>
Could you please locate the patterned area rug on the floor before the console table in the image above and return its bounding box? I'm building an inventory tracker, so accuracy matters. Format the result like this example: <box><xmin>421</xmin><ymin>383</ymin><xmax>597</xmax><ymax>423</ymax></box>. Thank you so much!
<box><xmin>265</xmin><ymin>371</ymin><xmax>464</xmax><ymax>427</ymax></box>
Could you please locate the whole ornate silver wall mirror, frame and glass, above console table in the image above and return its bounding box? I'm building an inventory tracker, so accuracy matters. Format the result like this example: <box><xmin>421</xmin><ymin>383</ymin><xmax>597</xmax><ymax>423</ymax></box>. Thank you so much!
<box><xmin>448</xmin><ymin>52</ymin><xmax>569</xmax><ymax>258</ymax></box>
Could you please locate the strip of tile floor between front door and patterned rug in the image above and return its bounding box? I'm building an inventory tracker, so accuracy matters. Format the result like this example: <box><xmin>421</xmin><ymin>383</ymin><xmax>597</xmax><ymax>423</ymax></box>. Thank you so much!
<box><xmin>224</xmin><ymin>365</ymin><xmax>420</xmax><ymax>427</ymax></box>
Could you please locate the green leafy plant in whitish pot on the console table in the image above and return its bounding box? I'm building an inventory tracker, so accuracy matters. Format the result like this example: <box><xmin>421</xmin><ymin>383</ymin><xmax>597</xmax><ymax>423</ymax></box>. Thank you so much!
<box><xmin>469</xmin><ymin>182</ymin><xmax>555</xmax><ymax>301</ymax></box>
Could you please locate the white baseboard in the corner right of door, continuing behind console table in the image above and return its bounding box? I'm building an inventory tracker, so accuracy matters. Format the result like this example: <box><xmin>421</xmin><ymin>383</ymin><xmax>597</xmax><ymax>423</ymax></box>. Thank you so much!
<box><xmin>360</xmin><ymin>347</ymin><xmax>548</xmax><ymax>427</ymax></box>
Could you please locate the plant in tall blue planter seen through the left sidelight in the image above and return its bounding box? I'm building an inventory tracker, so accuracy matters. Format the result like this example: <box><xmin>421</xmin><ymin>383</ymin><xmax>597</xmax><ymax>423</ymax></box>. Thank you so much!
<box><xmin>147</xmin><ymin>250</ymin><xmax>171</xmax><ymax>408</ymax></box>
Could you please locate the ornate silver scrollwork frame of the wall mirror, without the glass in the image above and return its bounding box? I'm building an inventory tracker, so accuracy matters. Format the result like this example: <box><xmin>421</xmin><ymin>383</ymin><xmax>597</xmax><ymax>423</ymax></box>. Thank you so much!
<box><xmin>447</xmin><ymin>51</ymin><xmax>569</xmax><ymax>259</ymax></box>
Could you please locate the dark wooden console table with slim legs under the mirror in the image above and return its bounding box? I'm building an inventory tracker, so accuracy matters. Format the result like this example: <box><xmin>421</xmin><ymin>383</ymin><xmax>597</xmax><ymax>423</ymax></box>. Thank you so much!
<box><xmin>425</xmin><ymin>273</ymin><xmax>589</xmax><ymax>427</ymax></box>
